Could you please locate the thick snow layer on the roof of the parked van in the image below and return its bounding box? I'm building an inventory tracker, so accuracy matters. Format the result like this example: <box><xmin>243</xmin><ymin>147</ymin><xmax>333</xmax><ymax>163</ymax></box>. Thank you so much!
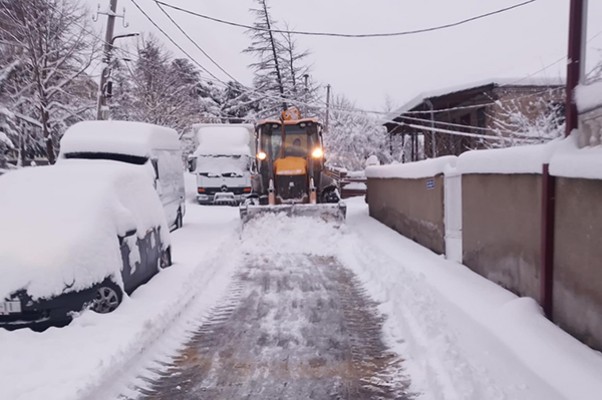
<box><xmin>61</xmin><ymin>121</ymin><xmax>180</xmax><ymax>157</ymax></box>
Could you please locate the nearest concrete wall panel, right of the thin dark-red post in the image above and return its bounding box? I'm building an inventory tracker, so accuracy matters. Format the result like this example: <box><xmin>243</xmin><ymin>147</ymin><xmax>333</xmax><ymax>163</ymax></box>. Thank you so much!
<box><xmin>553</xmin><ymin>178</ymin><xmax>602</xmax><ymax>349</ymax></box>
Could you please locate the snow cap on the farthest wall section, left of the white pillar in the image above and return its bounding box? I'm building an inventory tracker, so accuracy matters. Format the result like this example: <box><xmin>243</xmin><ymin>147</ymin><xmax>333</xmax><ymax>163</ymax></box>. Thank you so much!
<box><xmin>366</xmin><ymin>156</ymin><xmax>457</xmax><ymax>179</ymax></box>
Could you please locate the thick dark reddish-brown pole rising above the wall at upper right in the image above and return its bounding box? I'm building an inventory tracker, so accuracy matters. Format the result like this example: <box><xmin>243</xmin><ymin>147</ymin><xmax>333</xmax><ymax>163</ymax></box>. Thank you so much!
<box><xmin>565</xmin><ymin>0</ymin><xmax>587</xmax><ymax>136</ymax></box>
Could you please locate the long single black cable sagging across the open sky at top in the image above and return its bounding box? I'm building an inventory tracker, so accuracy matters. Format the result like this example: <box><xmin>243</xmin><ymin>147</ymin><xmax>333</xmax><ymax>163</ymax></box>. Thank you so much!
<box><xmin>154</xmin><ymin>0</ymin><xmax>536</xmax><ymax>38</ymax></box>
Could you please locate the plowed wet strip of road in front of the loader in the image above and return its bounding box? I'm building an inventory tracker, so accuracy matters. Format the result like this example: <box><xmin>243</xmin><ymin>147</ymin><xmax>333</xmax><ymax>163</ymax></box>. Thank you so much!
<box><xmin>134</xmin><ymin>253</ymin><xmax>409</xmax><ymax>400</ymax></box>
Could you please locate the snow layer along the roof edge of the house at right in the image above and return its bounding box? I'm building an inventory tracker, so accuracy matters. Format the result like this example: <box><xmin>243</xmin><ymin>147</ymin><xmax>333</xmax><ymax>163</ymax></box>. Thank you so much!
<box><xmin>385</xmin><ymin>78</ymin><xmax>564</xmax><ymax>121</ymax></box>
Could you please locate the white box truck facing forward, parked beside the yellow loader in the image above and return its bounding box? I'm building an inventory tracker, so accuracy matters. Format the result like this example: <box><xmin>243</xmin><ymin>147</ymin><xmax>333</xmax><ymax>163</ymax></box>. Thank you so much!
<box><xmin>188</xmin><ymin>124</ymin><xmax>255</xmax><ymax>205</ymax></box>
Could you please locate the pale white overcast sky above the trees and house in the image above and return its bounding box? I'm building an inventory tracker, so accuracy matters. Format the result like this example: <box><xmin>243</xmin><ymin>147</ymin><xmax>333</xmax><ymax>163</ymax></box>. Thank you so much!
<box><xmin>103</xmin><ymin>0</ymin><xmax>602</xmax><ymax>110</ymax></box>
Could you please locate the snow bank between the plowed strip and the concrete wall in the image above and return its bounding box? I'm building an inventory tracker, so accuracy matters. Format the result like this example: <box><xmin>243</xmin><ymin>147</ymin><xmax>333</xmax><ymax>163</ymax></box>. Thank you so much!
<box><xmin>338</xmin><ymin>199</ymin><xmax>602</xmax><ymax>400</ymax></box>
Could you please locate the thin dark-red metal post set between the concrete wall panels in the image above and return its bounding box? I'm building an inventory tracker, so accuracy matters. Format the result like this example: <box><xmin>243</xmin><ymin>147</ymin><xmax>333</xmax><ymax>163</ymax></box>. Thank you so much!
<box><xmin>539</xmin><ymin>164</ymin><xmax>556</xmax><ymax>319</ymax></box>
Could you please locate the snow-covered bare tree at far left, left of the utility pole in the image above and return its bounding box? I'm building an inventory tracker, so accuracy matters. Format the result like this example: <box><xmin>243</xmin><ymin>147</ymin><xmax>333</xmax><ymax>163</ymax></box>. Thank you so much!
<box><xmin>0</xmin><ymin>0</ymin><xmax>98</xmax><ymax>163</ymax></box>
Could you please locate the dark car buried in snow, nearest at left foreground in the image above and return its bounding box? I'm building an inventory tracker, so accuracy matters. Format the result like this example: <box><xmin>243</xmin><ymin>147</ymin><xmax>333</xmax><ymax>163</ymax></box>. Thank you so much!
<box><xmin>0</xmin><ymin>161</ymin><xmax>171</xmax><ymax>330</ymax></box>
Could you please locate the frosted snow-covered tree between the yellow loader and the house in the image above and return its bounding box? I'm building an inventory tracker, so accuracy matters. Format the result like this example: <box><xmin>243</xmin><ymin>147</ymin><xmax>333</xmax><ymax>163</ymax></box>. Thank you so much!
<box><xmin>324</xmin><ymin>95</ymin><xmax>391</xmax><ymax>171</ymax></box>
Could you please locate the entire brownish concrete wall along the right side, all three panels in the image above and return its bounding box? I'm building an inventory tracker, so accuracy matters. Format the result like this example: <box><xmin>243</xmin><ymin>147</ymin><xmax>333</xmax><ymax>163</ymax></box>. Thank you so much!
<box><xmin>367</xmin><ymin>174</ymin><xmax>602</xmax><ymax>350</ymax></box>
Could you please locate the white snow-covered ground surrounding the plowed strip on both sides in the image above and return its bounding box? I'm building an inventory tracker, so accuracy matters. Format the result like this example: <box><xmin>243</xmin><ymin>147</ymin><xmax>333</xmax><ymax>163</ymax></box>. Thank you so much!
<box><xmin>0</xmin><ymin>176</ymin><xmax>602</xmax><ymax>400</ymax></box>
